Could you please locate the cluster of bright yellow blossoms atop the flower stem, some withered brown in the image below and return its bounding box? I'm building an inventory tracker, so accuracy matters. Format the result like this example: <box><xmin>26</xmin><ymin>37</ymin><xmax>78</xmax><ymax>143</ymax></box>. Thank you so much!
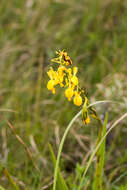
<box><xmin>47</xmin><ymin>50</ymin><xmax>90</xmax><ymax>124</ymax></box>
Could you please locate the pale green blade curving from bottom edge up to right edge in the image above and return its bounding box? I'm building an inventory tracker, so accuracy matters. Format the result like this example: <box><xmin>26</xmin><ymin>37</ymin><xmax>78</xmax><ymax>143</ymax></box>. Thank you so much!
<box><xmin>78</xmin><ymin>113</ymin><xmax>127</xmax><ymax>190</ymax></box>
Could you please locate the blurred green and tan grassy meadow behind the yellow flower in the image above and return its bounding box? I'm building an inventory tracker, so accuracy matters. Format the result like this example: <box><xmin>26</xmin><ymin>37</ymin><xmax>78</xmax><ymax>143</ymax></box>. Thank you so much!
<box><xmin>0</xmin><ymin>0</ymin><xmax>127</xmax><ymax>190</ymax></box>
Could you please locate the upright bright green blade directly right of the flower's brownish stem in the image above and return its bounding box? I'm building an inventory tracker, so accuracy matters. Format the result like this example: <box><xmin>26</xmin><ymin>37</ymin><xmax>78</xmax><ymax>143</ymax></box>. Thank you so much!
<box><xmin>93</xmin><ymin>114</ymin><xmax>108</xmax><ymax>190</ymax></box>
